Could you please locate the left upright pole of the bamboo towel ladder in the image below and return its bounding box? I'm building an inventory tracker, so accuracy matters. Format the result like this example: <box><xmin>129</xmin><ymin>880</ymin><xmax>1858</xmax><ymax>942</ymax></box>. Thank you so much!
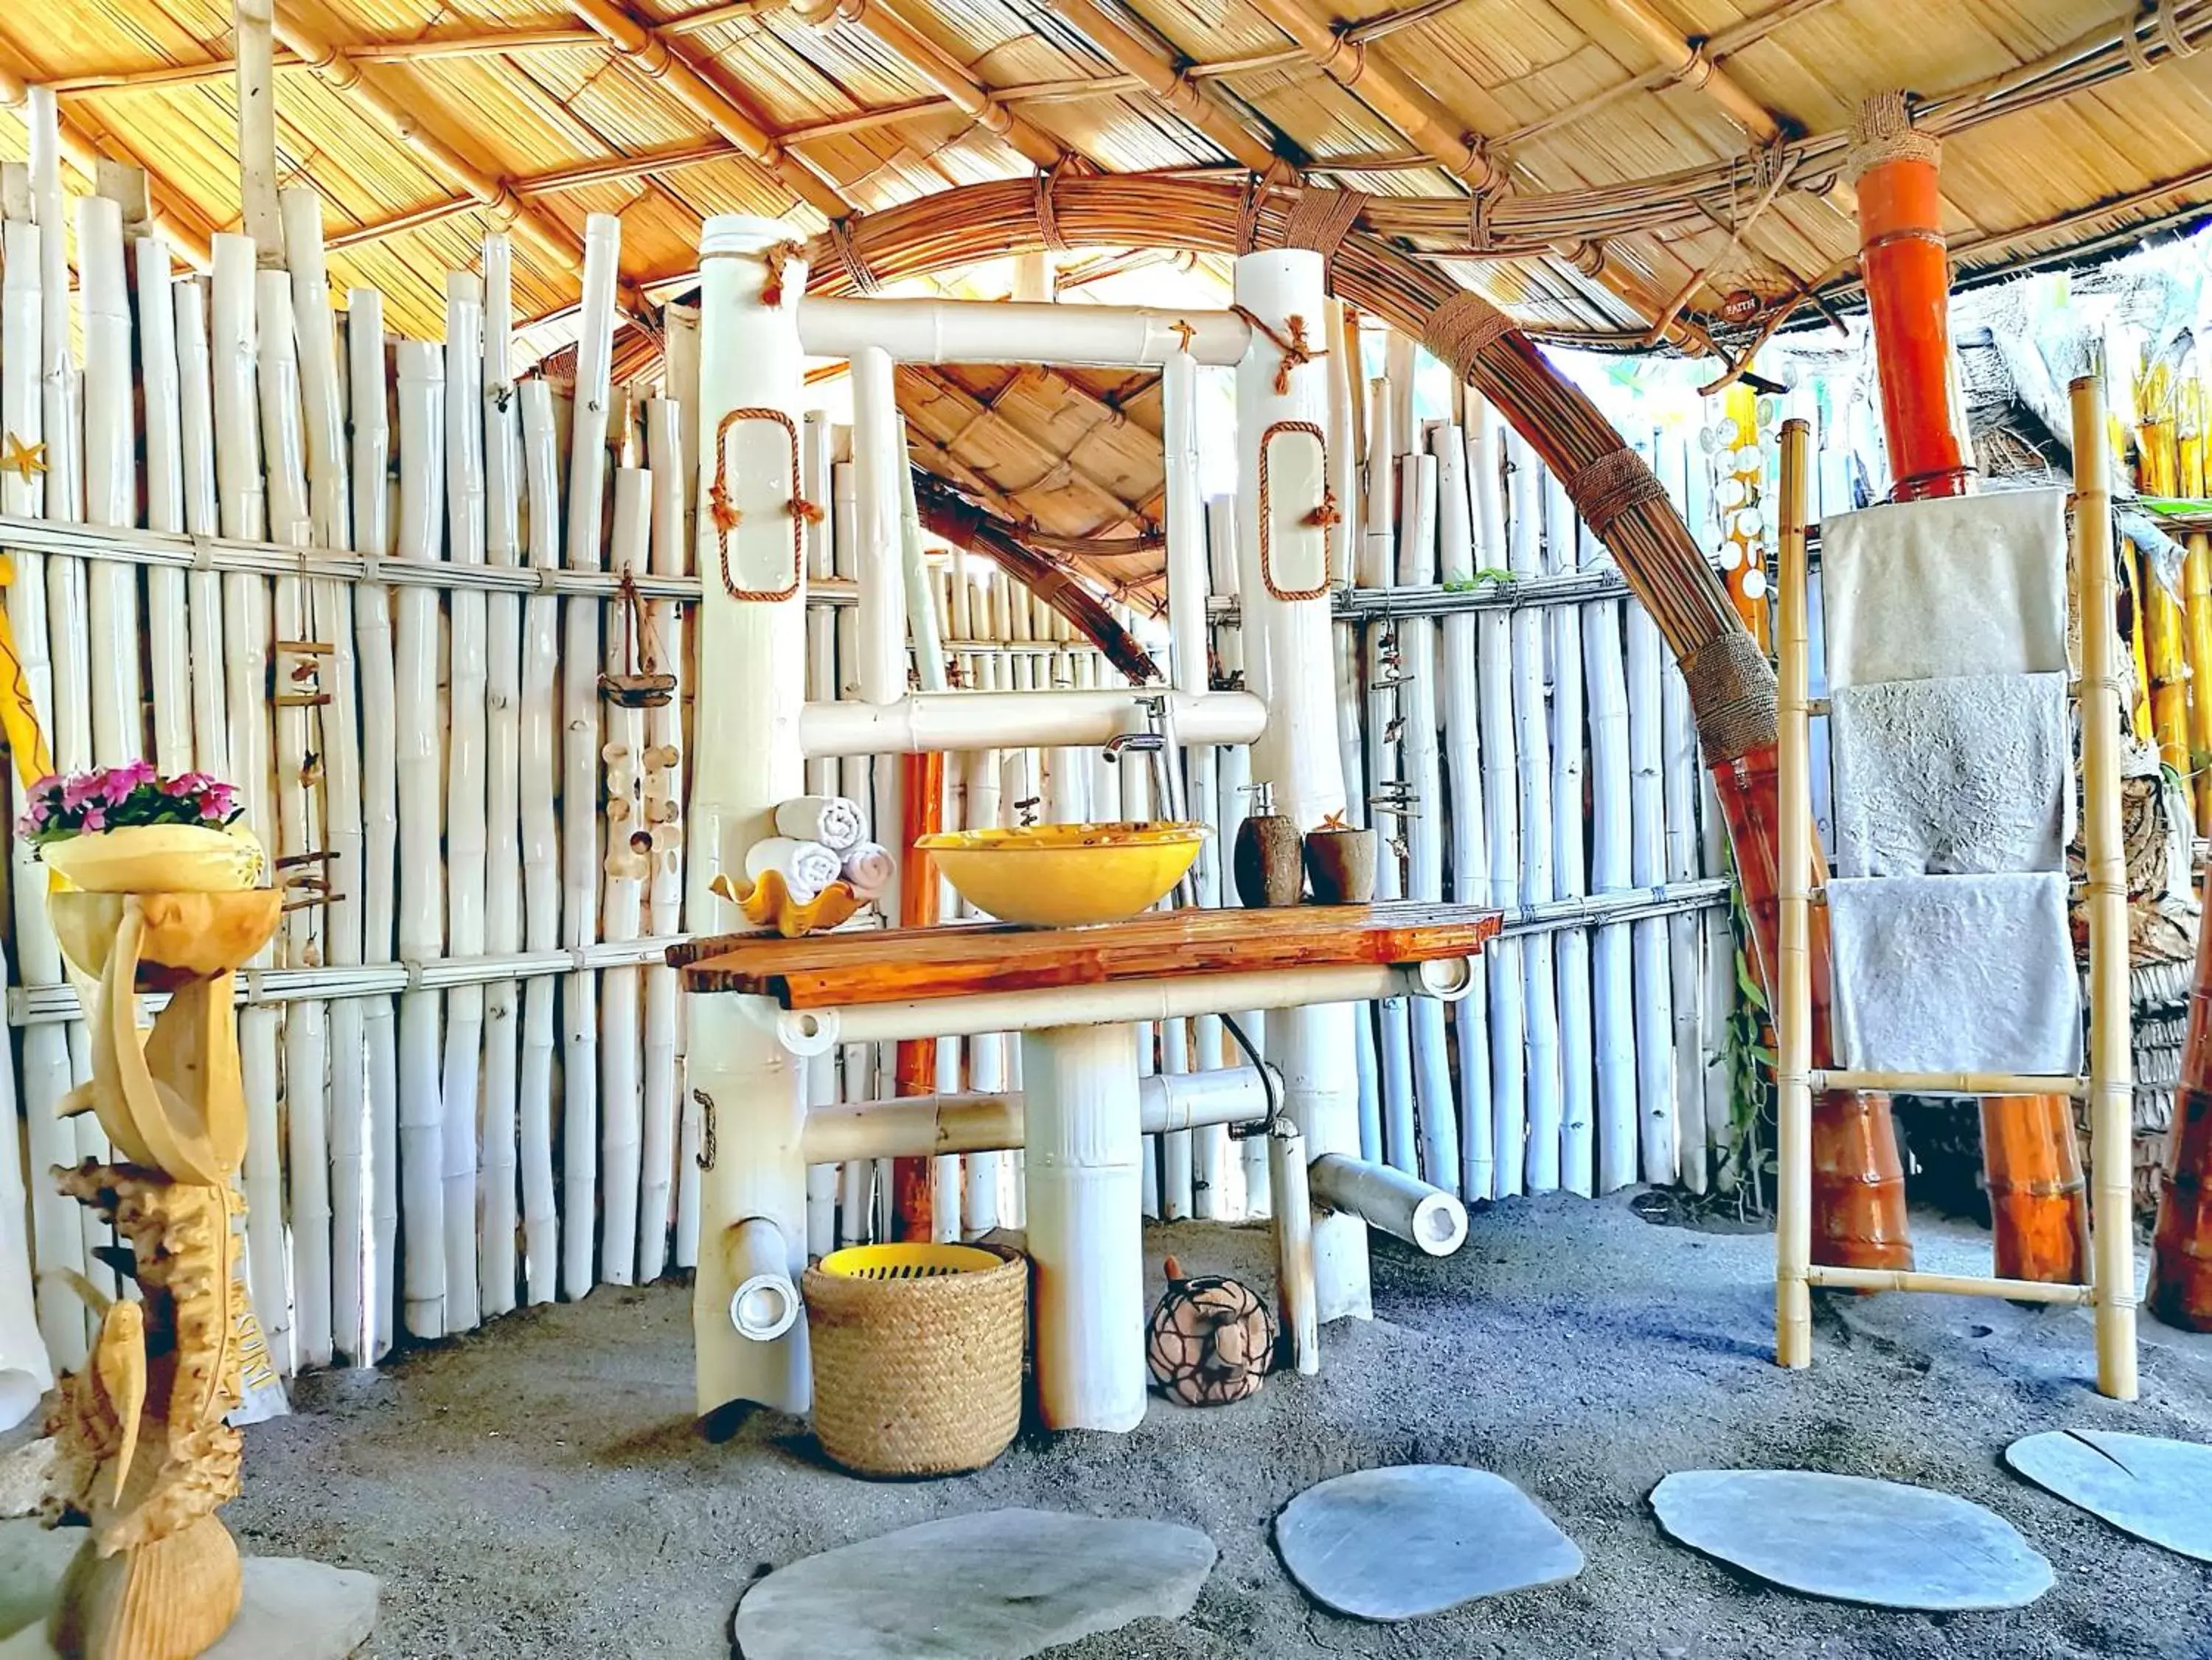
<box><xmin>1774</xmin><ymin>420</ymin><xmax>1816</xmax><ymax>1370</ymax></box>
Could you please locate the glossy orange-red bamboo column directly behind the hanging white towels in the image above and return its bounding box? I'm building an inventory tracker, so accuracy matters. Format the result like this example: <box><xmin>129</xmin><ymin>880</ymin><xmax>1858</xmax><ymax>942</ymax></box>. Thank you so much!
<box><xmin>1851</xmin><ymin>93</ymin><xmax>2088</xmax><ymax>1284</ymax></box>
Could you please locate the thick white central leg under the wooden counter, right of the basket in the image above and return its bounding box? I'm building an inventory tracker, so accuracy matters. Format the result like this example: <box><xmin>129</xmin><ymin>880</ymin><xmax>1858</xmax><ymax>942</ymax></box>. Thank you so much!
<box><xmin>1022</xmin><ymin>1025</ymin><xmax>1146</xmax><ymax>1430</ymax></box>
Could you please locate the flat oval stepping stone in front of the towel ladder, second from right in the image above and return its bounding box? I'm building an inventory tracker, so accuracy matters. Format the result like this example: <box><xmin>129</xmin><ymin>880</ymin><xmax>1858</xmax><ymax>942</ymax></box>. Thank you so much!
<box><xmin>1652</xmin><ymin>1470</ymin><xmax>2051</xmax><ymax>1611</ymax></box>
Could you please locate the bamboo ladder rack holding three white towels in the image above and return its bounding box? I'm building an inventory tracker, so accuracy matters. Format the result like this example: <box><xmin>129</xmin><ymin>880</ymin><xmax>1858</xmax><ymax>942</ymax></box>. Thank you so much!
<box><xmin>1774</xmin><ymin>376</ymin><xmax>2137</xmax><ymax>1401</ymax></box>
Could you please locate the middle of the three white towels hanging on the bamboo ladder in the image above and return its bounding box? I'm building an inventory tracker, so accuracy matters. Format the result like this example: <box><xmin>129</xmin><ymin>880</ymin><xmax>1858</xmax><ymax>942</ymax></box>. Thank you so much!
<box><xmin>1827</xmin><ymin>674</ymin><xmax>2073</xmax><ymax>875</ymax></box>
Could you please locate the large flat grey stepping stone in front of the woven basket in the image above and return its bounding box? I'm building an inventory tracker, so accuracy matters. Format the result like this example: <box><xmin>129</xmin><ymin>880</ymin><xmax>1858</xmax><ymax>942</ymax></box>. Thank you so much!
<box><xmin>737</xmin><ymin>1510</ymin><xmax>1219</xmax><ymax>1660</ymax></box>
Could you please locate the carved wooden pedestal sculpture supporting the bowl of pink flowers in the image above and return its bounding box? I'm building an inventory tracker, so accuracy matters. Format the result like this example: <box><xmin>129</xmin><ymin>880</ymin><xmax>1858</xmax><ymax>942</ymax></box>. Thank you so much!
<box><xmin>49</xmin><ymin>888</ymin><xmax>281</xmax><ymax>1660</ymax></box>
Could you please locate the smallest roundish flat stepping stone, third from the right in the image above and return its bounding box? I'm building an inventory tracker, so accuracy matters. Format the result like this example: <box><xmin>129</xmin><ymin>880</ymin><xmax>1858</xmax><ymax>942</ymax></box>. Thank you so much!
<box><xmin>1274</xmin><ymin>1463</ymin><xmax>1582</xmax><ymax>1620</ymax></box>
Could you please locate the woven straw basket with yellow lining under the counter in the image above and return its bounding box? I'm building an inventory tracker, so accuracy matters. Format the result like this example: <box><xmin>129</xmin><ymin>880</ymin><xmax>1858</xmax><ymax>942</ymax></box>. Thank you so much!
<box><xmin>805</xmin><ymin>1244</ymin><xmax>1029</xmax><ymax>1476</ymax></box>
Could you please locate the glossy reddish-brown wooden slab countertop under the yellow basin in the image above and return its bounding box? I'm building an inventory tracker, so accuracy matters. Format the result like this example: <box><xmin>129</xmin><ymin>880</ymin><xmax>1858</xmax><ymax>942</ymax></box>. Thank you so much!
<box><xmin>668</xmin><ymin>902</ymin><xmax>1502</xmax><ymax>1008</ymax></box>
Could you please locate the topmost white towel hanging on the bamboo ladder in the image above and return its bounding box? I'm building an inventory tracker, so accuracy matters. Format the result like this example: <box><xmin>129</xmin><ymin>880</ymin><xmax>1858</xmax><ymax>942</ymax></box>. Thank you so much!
<box><xmin>1820</xmin><ymin>491</ymin><xmax>2066</xmax><ymax>692</ymax></box>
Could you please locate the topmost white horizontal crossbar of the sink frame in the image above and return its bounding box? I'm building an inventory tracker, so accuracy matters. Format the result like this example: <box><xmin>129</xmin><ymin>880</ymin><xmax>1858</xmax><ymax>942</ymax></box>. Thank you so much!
<box><xmin>799</xmin><ymin>299</ymin><xmax>1256</xmax><ymax>369</ymax></box>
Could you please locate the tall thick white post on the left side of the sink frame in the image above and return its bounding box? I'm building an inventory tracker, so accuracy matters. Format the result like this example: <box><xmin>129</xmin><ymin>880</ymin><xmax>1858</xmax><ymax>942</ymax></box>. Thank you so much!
<box><xmin>686</xmin><ymin>215</ymin><xmax>812</xmax><ymax>1412</ymax></box>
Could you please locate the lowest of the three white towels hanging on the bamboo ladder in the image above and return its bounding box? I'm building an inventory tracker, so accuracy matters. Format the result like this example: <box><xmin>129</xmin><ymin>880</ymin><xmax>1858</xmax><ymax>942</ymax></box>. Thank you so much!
<box><xmin>1827</xmin><ymin>873</ymin><xmax>2081</xmax><ymax>1076</ymax></box>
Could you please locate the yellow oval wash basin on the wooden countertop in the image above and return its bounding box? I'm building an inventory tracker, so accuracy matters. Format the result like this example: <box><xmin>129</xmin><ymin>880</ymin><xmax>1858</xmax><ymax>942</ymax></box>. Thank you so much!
<box><xmin>916</xmin><ymin>825</ymin><xmax>1208</xmax><ymax>928</ymax></box>
